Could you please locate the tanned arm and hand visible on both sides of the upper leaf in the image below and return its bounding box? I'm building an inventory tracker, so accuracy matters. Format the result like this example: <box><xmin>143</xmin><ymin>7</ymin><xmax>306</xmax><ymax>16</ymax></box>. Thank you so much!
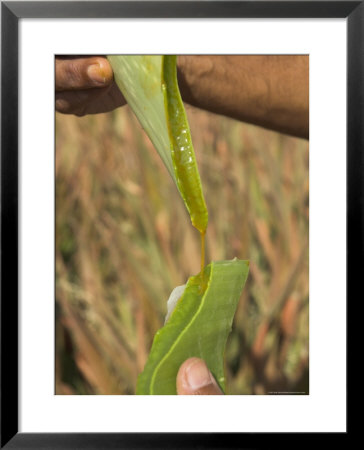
<box><xmin>56</xmin><ymin>55</ymin><xmax>309</xmax><ymax>138</ymax></box>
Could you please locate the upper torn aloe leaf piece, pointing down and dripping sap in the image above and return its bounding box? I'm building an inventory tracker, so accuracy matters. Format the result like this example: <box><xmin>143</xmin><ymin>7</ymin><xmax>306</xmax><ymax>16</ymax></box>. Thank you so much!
<box><xmin>108</xmin><ymin>55</ymin><xmax>208</xmax><ymax>233</ymax></box>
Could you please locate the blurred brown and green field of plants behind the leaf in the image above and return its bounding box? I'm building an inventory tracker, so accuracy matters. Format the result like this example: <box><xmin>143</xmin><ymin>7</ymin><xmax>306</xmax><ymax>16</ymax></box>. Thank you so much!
<box><xmin>55</xmin><ymin>98</ymin><xmax>309</xmax><ymax>395</ymax></box>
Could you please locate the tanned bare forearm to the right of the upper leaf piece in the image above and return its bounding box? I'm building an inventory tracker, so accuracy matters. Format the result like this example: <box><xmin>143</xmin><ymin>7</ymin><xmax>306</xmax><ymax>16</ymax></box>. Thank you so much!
<box><xmin>178</xmin><ymin>55</ymin><xmax>309</xmax><ymax>138</ymax></box>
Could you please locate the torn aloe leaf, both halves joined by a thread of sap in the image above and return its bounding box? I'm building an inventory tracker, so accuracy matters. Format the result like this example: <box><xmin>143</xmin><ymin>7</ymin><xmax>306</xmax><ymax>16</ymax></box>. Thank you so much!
<box><xmin>108</xmin><ymin>55</ymin><xmax>249</xmax><ymax>395</ymax></box>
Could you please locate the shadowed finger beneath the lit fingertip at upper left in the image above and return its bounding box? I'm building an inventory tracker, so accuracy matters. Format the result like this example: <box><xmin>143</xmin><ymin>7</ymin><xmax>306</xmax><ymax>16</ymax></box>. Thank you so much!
<box><xmin>55</xmin><ymin>83</ymin><xmax>126</xmax><ymax>116</ymax></box>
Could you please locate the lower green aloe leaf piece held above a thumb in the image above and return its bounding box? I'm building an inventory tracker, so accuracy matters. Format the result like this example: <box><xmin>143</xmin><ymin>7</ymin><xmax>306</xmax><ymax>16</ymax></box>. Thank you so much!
<box><xmin>136</xmin><ymin>259</ymin><xmax>249</xmax><ymax>395</ymax></box>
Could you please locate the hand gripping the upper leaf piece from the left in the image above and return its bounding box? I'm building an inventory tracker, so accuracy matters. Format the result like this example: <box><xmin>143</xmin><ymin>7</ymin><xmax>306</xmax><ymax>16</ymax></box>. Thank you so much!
<box><xmin>55</xmin><ymin>56</ymin><xmax>126</xmax><ymax>116</ymax></box>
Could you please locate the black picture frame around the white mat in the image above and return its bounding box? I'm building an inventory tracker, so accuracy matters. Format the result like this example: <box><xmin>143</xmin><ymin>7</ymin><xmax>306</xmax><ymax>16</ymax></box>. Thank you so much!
<box><xmin>0</xmin><ymin>1</ymin><xmax>356</xmax><ymax>449</ymax></box>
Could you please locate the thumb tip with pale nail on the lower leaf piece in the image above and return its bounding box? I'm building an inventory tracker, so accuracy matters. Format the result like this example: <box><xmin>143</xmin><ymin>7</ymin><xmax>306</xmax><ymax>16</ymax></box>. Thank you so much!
<box><xmin>177</xmin><ymin>358</ymin><xmax>223</xmax><ymax>395</ymax></box>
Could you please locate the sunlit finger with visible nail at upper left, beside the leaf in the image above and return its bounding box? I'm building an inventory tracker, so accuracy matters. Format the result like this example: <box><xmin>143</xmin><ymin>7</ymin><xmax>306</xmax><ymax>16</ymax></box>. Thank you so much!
<box><xmin>55</xmin><ymin>56</ymin><xmax>113</xmax><ymax>91</ymax></box>
